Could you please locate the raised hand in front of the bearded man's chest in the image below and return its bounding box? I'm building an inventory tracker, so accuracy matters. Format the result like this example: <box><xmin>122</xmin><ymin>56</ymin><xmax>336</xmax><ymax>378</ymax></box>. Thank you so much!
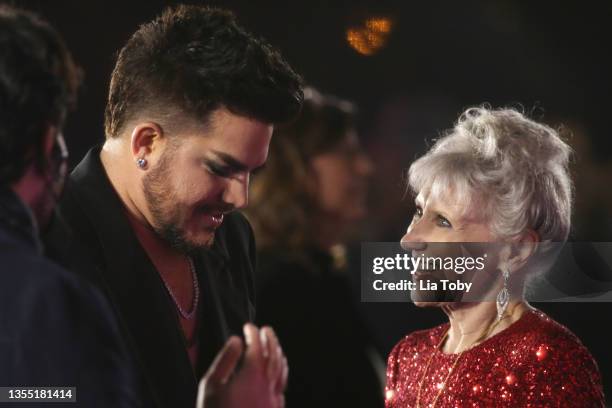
<box><xmin>196</xmin><ymin>324</ymin><xmax>288</xmax><ymax>408</ymax></box>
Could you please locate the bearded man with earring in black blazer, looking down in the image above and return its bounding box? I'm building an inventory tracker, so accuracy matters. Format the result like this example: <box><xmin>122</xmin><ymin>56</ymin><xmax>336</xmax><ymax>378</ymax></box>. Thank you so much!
<box><xmin>49</xmin><ymin>6</ymin><xmax>303</xmax><ymax>408</ymax></box>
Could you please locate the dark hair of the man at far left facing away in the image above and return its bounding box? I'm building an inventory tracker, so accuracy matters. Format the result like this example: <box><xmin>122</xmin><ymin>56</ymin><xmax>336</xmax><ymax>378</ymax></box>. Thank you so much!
<box><xmin>0</xmin><ymin>5</ymin><xmax>81</xmax><ymax>185</ymax></box>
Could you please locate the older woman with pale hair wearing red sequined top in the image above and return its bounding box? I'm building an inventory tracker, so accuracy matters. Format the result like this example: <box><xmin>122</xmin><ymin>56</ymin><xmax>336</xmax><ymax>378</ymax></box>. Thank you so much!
<box><xmin>386</xmin><ymin>108</ymin><xmax>604</xmax><ymax>407</ymax></box>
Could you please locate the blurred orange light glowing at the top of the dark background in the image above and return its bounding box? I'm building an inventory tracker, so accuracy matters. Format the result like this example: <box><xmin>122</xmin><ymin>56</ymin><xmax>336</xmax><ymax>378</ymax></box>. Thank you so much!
<box><xmin>346</xmin><ymin>17</ymin><xmax>393</xmax><ymax>56</ymax></box>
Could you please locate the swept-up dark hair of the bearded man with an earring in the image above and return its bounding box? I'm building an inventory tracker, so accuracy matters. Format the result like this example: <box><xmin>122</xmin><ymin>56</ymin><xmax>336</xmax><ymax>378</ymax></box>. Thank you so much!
<box><xmin>105</xmin><ymin>5</ymin><xmax>303</xmax><ymax>137</ymax></box>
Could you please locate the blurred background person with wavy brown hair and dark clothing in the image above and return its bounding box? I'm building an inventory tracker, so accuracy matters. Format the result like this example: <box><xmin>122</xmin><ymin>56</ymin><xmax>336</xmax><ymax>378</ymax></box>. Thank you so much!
<box><xmin>247</xmin><ymin>88</ymin><xmax>383</xmax><ymax>408</ymax></box>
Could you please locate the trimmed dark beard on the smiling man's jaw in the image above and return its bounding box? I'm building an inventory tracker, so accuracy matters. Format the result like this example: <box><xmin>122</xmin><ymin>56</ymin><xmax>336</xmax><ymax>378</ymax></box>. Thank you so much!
<box><xmin>143</xmin><ymin>152</ymin><xmax>214</xmax><ymax>254</ymax></box>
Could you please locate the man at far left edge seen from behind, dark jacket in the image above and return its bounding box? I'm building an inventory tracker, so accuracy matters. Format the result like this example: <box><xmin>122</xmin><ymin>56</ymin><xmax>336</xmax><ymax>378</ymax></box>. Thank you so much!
<box><xmin>0</xmin><ymin>6</ymin><xmax>138</xmax><ymax>407</ymax></box>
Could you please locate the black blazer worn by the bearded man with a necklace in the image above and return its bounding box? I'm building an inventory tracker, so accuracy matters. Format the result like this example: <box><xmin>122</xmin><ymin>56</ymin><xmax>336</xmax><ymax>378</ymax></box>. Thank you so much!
<box><xmin>45</xmin><ymin>147</ymin><xmax>255</xmax><ymax>408</ymax></box>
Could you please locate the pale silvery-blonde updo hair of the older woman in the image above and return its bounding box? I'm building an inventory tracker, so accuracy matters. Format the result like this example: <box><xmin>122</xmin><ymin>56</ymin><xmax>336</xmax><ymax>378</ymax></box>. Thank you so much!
<box><xmin>408</xmin><ymin>106</ymin><xmax>572</xmax><ymax>242</ymax></box>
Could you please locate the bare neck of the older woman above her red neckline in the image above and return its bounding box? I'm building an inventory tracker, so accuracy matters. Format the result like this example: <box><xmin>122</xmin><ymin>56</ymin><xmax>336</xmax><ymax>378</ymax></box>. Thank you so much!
<box><xmin>442</xmin><ymin>299</ymin><xmax>529</xmax><ymax>354</ymax></box>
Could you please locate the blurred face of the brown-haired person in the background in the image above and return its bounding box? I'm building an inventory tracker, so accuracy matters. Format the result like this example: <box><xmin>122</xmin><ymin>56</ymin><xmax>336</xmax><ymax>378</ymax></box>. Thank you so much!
<box><xmin>310</xmin><ymin>132</ymin><xmax>373</xmax><ymax>222</ymax></box>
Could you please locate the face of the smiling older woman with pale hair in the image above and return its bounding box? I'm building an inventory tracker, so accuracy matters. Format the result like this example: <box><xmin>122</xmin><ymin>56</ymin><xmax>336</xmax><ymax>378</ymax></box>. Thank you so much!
<box><xmin>401</xmin><ymin>192</ymin><xmax>499</xmax><ymax>306</ymax></box>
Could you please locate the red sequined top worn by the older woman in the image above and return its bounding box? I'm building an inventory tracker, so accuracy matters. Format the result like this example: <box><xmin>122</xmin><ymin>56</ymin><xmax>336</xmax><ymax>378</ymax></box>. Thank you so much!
<box><xmin>386</xmin><ymin>310</ymin><xmax>604</xmax><ymax>408</ymax></box>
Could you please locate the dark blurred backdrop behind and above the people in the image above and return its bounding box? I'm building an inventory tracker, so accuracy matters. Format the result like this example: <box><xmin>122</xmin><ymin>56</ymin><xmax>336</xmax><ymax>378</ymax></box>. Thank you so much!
<box><xmin>12</xmin><ymin>0</ymin><xmax>612</xmax><ymax>402</ymax></box>
